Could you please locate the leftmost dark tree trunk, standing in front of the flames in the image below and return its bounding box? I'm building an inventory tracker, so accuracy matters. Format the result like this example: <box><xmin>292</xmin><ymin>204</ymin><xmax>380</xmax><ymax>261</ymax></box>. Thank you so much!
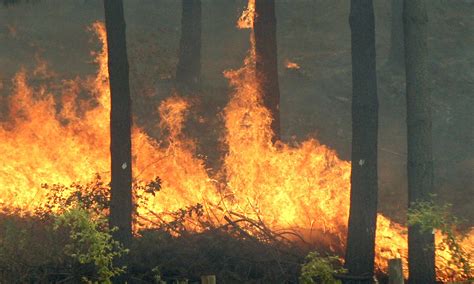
<box><xmin>104</xmin><ymin>0</ymin><xmax>132</xmax><ymax>247</ymax></box>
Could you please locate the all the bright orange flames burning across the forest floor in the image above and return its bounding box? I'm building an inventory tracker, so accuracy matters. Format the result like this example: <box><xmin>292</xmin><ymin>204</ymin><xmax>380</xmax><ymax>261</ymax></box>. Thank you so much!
<box><xmin>0</xmin><ymin>11</ymin><xmax>474</xmax><ymax>284</ymax></box>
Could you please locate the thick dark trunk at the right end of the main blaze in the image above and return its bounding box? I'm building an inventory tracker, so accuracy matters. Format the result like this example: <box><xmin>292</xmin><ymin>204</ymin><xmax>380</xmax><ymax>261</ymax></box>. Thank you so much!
<box><xmin>345</xmin><ymin>0</ymin><xmax>378</xmax><ymax>283</ymax></box>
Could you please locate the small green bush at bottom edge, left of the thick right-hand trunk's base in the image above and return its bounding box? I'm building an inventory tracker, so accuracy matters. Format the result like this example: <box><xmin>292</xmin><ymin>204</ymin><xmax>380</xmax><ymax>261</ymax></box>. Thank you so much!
<box><xmin>299</xmin><ymin>252</ymin><xmax>346</xmax><ymax>284</ymax></box>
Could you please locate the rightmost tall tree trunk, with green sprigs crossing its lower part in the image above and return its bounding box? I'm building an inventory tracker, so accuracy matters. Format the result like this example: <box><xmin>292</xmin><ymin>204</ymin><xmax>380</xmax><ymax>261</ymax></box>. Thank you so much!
<box><xmin>403</xmin><ymin>0</ymin><xmax>435</xmax><ymax>284</ymax></box>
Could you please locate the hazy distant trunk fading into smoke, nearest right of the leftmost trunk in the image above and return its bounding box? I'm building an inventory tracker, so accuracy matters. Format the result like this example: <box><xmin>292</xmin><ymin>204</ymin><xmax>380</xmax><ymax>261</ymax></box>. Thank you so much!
<box><xmin>176</xmin><ymin>0</ymin><xmax>201</xmax><ymax>93</ymax></box>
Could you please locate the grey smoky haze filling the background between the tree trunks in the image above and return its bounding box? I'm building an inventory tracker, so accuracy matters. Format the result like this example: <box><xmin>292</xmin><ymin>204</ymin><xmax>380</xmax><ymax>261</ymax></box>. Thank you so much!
<box><xmin>0</xmin><ymin>0</ymin><xmax>474</xmax><ymax>225</ymax></box>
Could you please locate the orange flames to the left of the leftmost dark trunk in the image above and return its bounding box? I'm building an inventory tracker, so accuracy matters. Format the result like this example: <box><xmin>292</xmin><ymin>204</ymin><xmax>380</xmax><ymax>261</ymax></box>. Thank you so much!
<box><xmin>0</xmin><ymin>23</ymin><xmax>109</xmax><ymax>210</ymax></box>
